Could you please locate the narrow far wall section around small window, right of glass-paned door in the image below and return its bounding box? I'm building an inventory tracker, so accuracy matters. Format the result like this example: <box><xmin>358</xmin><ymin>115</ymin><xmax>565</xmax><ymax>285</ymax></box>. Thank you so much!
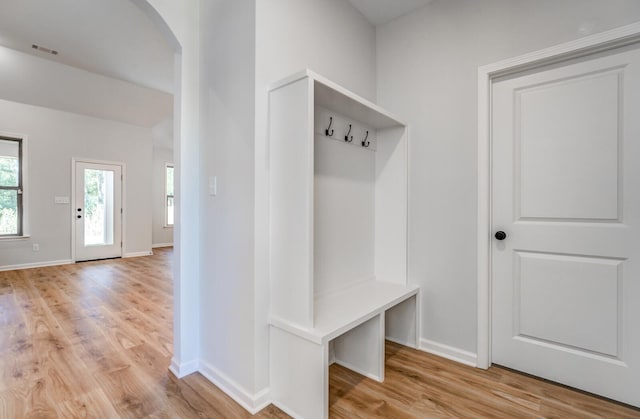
<box><xmin>151</xmin><ymin>145</ymin><xmax>173</xmax><ymax>247</ymax></box>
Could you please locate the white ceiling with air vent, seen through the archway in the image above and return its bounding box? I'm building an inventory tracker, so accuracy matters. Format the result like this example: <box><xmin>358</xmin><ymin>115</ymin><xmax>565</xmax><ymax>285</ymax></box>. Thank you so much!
<box><xmin>0</xmin><ymin>0</ymin><xmax>173</xmax><ymax>93</ymax></box>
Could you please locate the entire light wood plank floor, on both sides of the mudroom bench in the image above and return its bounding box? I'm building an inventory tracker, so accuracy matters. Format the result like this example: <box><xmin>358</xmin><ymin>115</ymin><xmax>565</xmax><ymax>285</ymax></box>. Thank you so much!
<box><xmin>0</xmin><ymin>249</ymin><xmax>640</xmax><ymax>418</ymax></box>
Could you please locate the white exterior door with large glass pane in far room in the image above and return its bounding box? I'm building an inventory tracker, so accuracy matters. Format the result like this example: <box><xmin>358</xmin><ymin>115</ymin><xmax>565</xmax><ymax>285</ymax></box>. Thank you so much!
<box><xmin>73</xmin><ymin>161</ymin><xmax>122</xmax><ymax>261</ymax></box>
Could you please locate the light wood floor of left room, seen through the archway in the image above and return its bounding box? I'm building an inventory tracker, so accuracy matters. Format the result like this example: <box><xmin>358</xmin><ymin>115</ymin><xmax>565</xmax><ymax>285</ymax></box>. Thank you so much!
<box><xmin>0</xmin><ymin>249</ymin><xmax>288</xmax><ymax>419</ymax></box>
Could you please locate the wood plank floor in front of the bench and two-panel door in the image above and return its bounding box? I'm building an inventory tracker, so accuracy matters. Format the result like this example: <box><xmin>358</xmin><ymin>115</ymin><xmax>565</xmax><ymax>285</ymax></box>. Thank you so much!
<box><xmin>329</xmin><ymin>341</ymin><xmax>640</xmax><ymax>419</ymax></box>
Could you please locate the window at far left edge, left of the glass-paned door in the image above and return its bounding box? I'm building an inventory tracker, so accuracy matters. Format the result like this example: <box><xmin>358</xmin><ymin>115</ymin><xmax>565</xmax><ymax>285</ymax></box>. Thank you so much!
<box><xmin>0</xmin><ymin>136</ymin><xmax>24</xmax><ymax>237</ymax></box>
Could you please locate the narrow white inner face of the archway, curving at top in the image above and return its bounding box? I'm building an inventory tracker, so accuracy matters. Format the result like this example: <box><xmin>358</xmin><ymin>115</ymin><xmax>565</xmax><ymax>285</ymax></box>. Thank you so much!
<box><xmin>131</xmin><ymin>0</ymin><xmax>199</xmax><ymax>378</ymax></box>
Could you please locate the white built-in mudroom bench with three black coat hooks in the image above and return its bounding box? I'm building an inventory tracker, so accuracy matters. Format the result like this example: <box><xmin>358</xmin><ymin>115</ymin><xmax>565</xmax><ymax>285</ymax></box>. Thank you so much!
<box><xmin>269</xmin><ymin>70</ymin><xmax>419</xmax><ymax>418</ymax></box>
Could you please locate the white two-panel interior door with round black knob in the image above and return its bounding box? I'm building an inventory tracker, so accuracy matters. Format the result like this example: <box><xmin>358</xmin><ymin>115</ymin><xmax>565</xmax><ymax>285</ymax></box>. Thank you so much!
<box><xmin>491</xmin><ymin>47</ymin><xmax>640</xmax><ymax>406</ymax></box>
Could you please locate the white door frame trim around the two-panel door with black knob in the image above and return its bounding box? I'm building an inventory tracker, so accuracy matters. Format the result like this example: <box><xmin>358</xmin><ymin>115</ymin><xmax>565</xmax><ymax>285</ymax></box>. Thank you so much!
<box><xmin>476</xmin><ymin>22</ymin><xmax>640</xmax><ymax>369</ymax></box>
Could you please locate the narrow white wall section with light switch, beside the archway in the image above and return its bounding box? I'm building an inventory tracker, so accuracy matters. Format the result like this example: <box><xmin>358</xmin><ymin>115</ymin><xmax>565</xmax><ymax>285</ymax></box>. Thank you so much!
<box><xmin>199</xmin><ymin>0</ymin><xmax>255</xmax><ymax>404</ymax></box>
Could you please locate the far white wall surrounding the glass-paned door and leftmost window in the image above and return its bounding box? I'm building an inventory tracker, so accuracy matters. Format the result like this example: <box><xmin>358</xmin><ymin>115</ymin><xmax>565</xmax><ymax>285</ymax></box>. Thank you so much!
<box><xmin>0</xmin><ymin>100</ymin><xmax>151</xmax><ymax>267</ymax></box>
